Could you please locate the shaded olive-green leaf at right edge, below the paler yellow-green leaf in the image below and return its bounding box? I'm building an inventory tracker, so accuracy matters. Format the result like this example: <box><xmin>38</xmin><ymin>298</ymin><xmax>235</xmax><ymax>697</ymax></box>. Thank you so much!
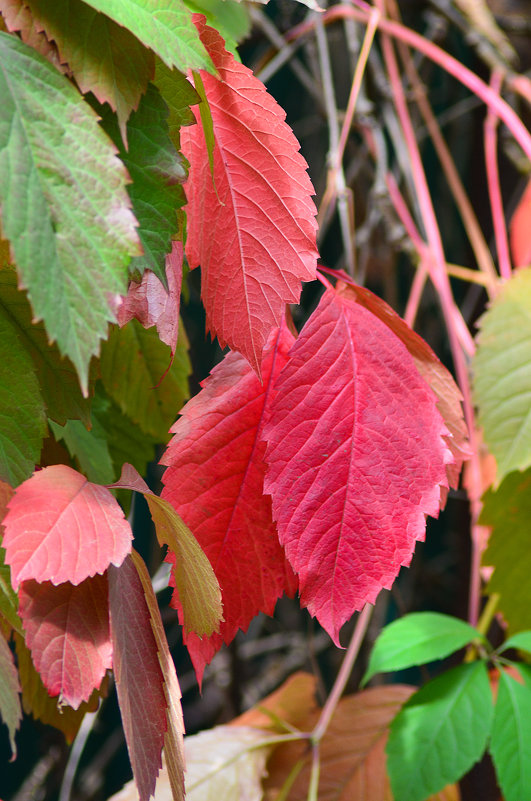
<box><xmin>480</xmin><ymin>469</ymin><xmax>531</xmax><ymax>631</ymax></box>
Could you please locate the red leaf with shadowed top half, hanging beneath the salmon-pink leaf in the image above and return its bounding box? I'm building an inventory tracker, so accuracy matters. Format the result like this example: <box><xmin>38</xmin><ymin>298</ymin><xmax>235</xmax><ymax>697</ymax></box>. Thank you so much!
<box><xmin>19</xmin><ymin>576</ymin><xmax>112</xmax><ymax>709</ymax></box>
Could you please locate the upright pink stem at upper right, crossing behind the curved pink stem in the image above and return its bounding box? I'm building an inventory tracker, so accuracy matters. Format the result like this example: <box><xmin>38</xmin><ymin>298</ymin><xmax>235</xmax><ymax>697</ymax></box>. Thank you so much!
<box><xmin>483</xmin><ymin>70</ymin><xmax>511</xmax><ymax>278</ymax></box>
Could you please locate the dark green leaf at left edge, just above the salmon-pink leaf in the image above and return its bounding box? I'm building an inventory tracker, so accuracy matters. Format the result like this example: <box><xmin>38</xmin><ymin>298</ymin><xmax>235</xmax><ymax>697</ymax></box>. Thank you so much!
<box><xmin>0</xmin><ymin>316</ymin><xmax>46</xmax><ymax>487</ymax></box>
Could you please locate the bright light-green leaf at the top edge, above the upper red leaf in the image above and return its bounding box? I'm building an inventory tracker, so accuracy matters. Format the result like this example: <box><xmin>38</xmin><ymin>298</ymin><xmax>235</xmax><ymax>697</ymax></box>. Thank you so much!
<box><xmin>79</xmin><ymin>0</ymin><xmax>214</xmax><ymax>74</ymax></box>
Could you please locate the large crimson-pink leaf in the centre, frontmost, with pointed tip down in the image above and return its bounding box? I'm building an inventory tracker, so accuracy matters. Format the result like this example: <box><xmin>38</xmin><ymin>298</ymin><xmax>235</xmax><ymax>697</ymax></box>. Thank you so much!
<box><xmin>264</xmin><ymin>290</ymin><xmax>452</xmax><ymax>643</ymax></box>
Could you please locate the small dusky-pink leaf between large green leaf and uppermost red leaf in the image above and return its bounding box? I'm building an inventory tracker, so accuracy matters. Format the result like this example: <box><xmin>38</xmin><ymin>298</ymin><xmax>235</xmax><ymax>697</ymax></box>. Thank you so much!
<box><xmin>112</xmin><ymin>242</ymin><xmax>183</xmax><ymax>354</ymax></box>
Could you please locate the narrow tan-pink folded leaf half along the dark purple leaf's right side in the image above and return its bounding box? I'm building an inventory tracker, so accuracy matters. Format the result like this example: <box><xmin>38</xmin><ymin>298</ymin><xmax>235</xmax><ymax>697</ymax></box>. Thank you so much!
<box><xmin>131</xmin><ymin>551</ymin><xmax>184</xmax><ymax>801</ymax></box>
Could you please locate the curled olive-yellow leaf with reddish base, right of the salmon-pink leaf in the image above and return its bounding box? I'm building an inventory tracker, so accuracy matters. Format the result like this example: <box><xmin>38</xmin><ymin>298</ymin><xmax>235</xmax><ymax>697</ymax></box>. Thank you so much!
<box><xmin>109</xmin><ymin>464</ymin><xmax>223</xmax><ymax>636</ymax></box>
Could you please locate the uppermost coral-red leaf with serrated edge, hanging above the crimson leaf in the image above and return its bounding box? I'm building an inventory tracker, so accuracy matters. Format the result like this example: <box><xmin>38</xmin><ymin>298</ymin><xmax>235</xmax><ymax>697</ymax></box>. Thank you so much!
<box><xmin>181</xmin><ymin>15</ymin><xmax>317</xmax><ymax>372</ymax></box>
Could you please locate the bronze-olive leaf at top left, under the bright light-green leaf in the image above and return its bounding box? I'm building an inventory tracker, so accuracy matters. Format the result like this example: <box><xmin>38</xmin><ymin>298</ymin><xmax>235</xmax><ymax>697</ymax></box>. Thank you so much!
<box><xmin>11</xmin><ymin>0</ymin><xmax>155</xmax><ymax>133</ymax></box>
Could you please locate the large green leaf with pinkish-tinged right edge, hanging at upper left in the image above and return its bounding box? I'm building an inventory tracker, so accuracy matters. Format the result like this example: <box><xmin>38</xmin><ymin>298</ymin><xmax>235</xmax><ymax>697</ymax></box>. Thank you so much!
<box><xmin>0</xmin><ymin>32</ymin><xmax>139</xmax><ymax>393</ymax></box>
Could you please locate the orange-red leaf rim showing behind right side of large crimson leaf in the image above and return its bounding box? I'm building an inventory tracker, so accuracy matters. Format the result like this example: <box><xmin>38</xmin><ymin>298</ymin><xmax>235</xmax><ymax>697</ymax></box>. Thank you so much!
<box><xmin>336</xmin><ymin>283</ymin><xmax>470</xmax><ymax>494</ymax></box>
